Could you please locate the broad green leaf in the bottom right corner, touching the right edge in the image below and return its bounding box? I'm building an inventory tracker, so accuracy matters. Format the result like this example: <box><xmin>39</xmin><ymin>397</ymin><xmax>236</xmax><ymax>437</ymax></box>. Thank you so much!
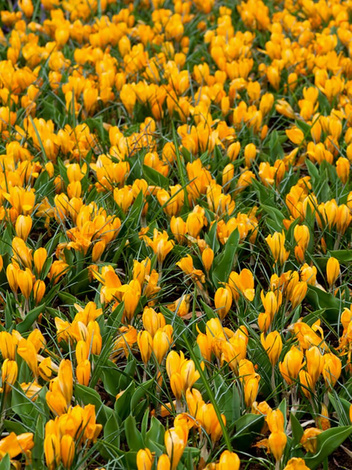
<box><xmin>304</xmin><ymin>426</ymin><xmax>352</xmax><ymax>470</ymax></box>
